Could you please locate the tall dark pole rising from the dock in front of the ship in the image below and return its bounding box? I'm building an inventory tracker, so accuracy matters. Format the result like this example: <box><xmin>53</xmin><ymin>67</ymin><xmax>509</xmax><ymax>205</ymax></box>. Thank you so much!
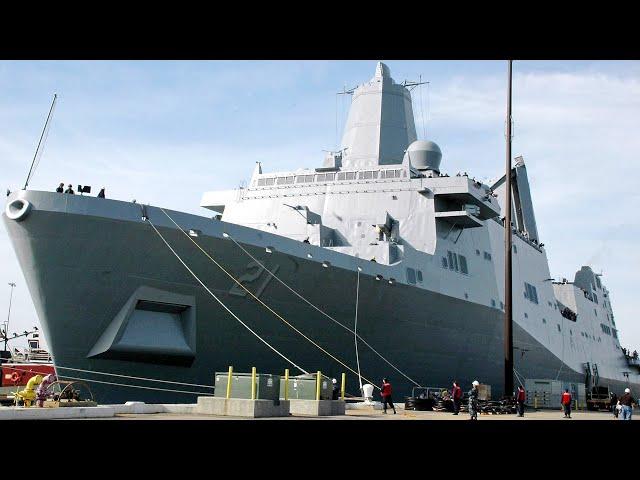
<box><xmin>504</xmin><ymin>60</ymin><xmax>513</xmax><ymax>397</ymax></box>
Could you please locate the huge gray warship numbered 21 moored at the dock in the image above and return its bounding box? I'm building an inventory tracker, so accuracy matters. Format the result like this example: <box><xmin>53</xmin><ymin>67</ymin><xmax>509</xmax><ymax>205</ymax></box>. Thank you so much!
<box><xmin>3</xmin><ymin>63</ymin><xmax>640</xmax><ymax>403</ymax></box>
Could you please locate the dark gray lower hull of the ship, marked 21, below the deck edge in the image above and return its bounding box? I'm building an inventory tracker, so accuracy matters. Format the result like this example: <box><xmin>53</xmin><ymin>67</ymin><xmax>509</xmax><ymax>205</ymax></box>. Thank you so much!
<box><xmin>3</xmin><ymin>191</ymin><xmax>632</xmax><ymax>403</ymax></box>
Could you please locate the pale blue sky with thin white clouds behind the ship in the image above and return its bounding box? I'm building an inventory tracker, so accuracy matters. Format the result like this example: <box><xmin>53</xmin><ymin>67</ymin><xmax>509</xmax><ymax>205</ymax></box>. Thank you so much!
<box><xmin>0</xmin><ymin>59</ymin><xmax>640</xmax><ymax>348</ymax></box>
